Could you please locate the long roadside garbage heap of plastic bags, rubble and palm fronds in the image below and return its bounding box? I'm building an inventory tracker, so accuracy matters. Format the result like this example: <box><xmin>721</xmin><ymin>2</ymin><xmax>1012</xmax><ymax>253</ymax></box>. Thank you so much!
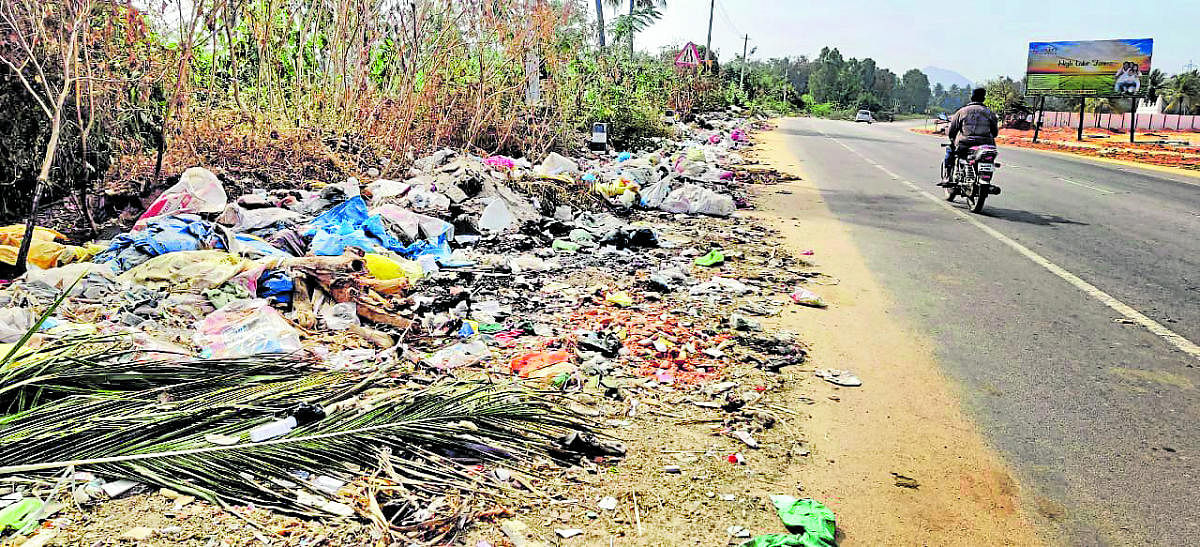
<box><xmin>0</xmin><ymin>112</ymin><xmax>823</xmax><ymax>541</ymax></box>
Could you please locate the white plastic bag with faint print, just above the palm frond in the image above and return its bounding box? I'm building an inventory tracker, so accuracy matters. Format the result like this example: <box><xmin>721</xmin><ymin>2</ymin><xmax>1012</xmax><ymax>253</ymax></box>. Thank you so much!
<box><xmin>192</xmin><ymin>299</ymin><xmax>300</xmax><ymax>359</ymax></box>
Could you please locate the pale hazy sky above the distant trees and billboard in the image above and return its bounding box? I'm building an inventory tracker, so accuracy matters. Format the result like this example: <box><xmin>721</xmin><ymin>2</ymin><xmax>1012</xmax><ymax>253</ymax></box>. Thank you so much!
<box><xmin>628</xmin><ymin>0</ymin><xmax>1200</xmax><ymax>82</ymax></box>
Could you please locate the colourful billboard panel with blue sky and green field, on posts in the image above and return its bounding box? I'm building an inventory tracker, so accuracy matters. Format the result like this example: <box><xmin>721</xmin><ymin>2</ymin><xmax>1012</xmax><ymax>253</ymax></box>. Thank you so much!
<box><xmin>1025</xmin><ymin>38</ymin><xmax>1154</xmax><ymax>97</ymax></box>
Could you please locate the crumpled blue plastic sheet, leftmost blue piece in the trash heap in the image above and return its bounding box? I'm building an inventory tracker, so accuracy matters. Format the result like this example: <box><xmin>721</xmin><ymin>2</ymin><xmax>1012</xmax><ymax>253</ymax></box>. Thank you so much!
<box><xmin>92</xmin><ymin>215</ymin><xmax>226</xmax><ymax>274</ymax></box>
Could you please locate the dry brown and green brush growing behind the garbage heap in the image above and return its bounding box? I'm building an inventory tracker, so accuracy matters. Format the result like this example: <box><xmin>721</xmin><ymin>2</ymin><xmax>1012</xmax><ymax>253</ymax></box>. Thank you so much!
<box><xmin>0</xmin><ymin>0</ymin><xmax>794</xmax><ymax>249</ymax></box>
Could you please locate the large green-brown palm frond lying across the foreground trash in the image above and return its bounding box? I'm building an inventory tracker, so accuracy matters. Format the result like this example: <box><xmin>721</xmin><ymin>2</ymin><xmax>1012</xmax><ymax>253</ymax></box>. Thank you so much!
<box><xmin>0</xmin><ymin>373</ymin><xmax>587</xmax><ymax>515</ymax></box>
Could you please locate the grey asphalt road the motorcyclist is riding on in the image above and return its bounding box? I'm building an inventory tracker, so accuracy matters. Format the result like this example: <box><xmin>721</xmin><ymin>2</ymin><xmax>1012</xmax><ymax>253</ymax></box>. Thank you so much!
<box><xmin>780</xmin><ymin>119</ymin><xmax>1200</xmax><ymax>545</ymax></box>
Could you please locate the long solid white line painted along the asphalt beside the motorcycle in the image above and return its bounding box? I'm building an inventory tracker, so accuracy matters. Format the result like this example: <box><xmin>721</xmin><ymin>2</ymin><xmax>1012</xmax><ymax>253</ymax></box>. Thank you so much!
<box><xmin>817</xmin><ymin>130</ymin><xmax>1200</xmax><ymax>360</ymax></box>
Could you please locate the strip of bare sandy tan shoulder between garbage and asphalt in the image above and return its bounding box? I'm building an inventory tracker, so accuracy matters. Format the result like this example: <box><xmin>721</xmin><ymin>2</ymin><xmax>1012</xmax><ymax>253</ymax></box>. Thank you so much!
<box><xmin>754</xmin><ymin>121</ymin><xmax>1043</xmax><ymax>545</ymax></box>
